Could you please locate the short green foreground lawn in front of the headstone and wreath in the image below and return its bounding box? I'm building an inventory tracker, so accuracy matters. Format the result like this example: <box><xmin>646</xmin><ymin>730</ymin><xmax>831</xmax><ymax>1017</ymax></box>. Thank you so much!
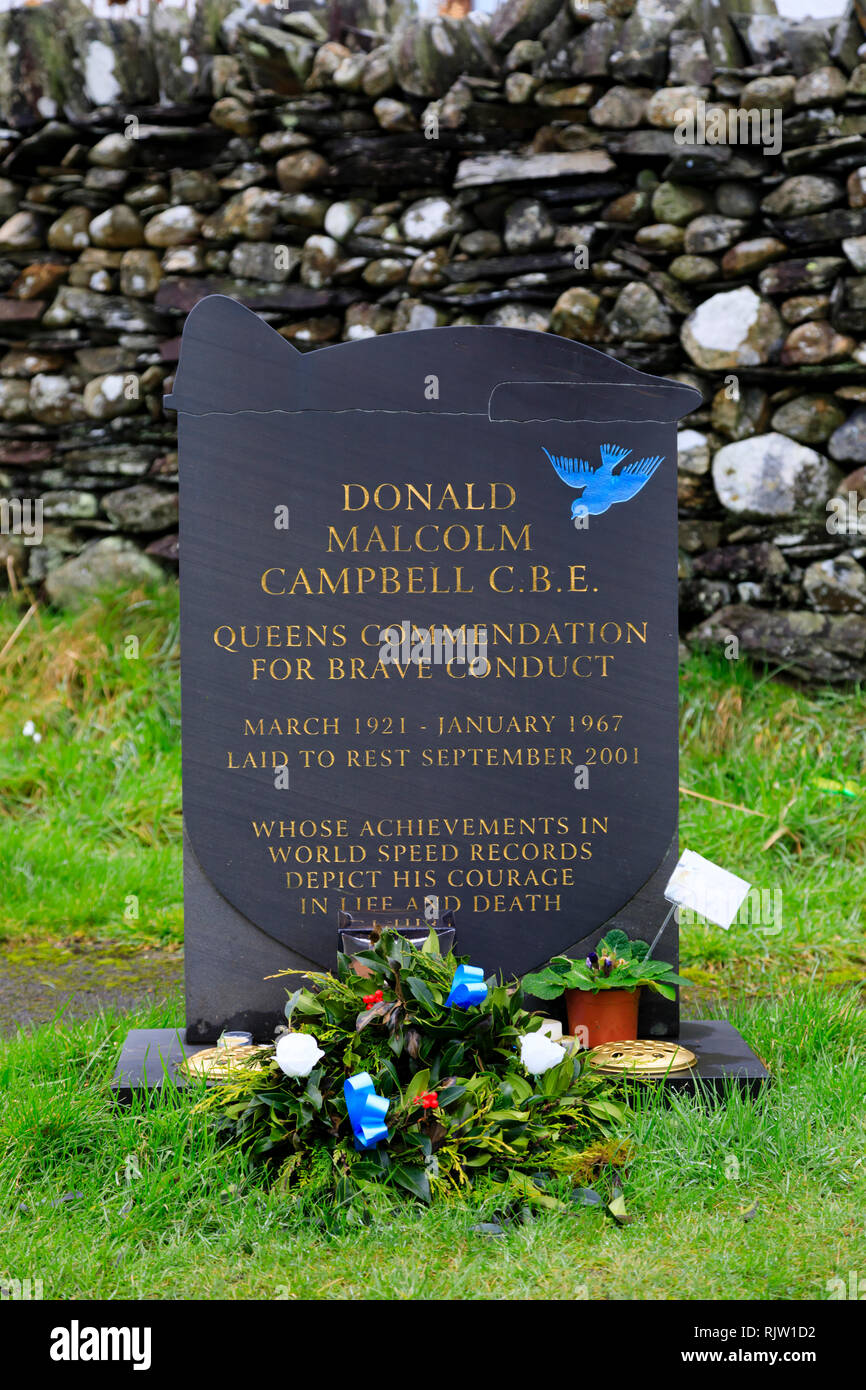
<box><xmin>0</xmin><ymin>990</ymin><xmax>866</xmax><ymax>1300</ymax></box>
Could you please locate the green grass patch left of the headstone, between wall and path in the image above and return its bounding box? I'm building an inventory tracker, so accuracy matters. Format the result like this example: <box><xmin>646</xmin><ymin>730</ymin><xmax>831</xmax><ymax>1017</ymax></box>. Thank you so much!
<box><xmin>0</xmin><ymin>588</ymin><xmax>183</xmax><ymax>941</ymax></box>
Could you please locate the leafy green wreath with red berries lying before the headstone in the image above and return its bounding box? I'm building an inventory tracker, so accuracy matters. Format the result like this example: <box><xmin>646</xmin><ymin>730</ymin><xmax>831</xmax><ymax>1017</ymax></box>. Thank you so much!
<box><xmin>199</xmin><ymin>931</ymin><xmax>626</xmax><ymax>1215</ymax></box>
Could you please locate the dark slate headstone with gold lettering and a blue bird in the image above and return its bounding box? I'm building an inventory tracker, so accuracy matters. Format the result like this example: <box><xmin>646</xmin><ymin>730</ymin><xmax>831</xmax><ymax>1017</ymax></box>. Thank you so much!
<box><xmin>167</xmin><ymin>304</ymin><xmax>699</xmax><ymax>1040</ymax></box>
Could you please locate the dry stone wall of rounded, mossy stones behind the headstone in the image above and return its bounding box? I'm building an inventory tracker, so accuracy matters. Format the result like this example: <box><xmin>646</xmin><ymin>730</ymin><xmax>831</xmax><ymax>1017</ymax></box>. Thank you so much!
<box><xmin>0</xmin><ymin>0</ymin><xmax>866</xmax><ymax>681</ymax></box>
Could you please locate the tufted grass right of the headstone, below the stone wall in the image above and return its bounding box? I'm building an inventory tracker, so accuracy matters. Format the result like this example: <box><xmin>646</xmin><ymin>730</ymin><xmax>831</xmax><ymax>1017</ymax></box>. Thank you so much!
<box><xmin>680</xmin><ymin>644</ymin><xmax>866</xmax><ymax>994</ymax></box>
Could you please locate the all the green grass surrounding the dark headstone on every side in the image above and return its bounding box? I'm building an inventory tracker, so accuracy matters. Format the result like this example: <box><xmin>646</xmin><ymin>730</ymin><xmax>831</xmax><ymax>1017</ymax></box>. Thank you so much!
<box><xmin>0</xmin><ymin>589</ymin><xmax>866</xmax><ymax>1300</ymax></box>
